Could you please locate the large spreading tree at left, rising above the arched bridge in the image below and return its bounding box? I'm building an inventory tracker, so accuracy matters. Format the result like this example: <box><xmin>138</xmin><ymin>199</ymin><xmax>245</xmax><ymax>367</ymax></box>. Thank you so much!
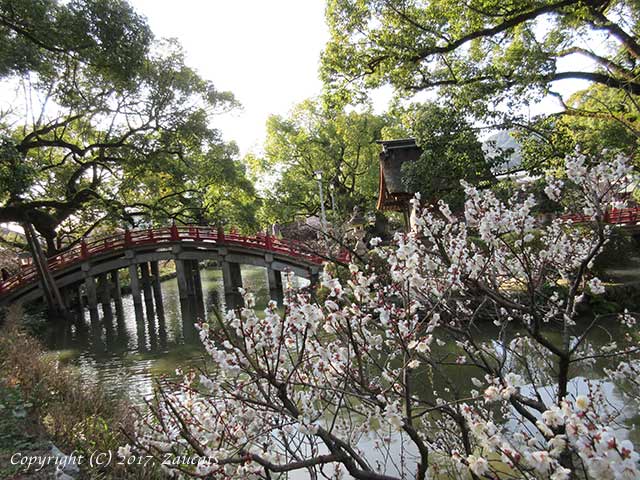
<box><xmin>0</xmin><ymin>0</ymin><xmax>252</xmax><ymax>253</ymax></box>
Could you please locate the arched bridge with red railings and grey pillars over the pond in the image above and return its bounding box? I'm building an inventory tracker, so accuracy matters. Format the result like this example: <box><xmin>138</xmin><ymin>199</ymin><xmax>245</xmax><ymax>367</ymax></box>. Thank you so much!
<box><xmin>0</xmin><ymin>225</ymin><xmax>324</xmax><ymax>322</ymax></box>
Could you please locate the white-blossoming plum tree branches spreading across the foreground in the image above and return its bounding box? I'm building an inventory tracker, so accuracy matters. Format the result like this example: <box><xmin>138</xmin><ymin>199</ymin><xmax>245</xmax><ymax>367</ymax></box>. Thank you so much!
<box><xmin>129</xmin><ymin>153</ymin><xmax>640</xmax><ymax>480</ymax></box>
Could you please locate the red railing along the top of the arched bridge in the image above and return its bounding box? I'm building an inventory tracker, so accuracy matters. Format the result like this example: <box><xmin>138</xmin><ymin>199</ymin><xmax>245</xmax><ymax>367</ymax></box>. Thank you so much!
<box><xmin>0</xmin><ymin>225</ymin><xmax>323</xmax><ymax>295</ymax></box>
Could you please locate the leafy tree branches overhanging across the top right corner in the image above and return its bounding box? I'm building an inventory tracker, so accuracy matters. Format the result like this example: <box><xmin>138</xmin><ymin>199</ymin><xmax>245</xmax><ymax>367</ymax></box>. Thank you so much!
<box><xmin>322</xmin><ymin>0</ymin><xmax>640</xmax><ymax>124</ymax></box>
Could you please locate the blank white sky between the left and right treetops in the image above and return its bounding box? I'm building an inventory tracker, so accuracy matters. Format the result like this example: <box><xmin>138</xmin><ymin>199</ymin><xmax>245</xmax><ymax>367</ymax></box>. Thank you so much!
<box><xmin>130</xmin><ymin>0</ymin><xmax>329</xmax><ymax>155</ymax></box>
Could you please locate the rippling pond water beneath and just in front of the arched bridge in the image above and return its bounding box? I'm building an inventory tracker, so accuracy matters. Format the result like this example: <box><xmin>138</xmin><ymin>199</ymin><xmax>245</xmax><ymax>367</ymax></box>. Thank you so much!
<box><xmin>42</xmin><ymin>266</ymin><xmax>278</xmax><ymax>402</ymax></box>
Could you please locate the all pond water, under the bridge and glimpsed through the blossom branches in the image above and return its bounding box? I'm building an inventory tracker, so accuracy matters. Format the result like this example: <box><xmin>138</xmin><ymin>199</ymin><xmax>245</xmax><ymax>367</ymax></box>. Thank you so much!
<box><xmin>41</xmin><ymin>266</ymin><xmax>640</xmax><ymax>445</ymax></box>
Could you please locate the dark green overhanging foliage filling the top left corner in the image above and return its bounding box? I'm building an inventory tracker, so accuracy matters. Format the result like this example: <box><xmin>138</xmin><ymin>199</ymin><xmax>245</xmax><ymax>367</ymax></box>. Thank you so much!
<box><xmin>0</xmin><ymin>0</ymin><xmax>152</xmax><ymax>82</ymax></box>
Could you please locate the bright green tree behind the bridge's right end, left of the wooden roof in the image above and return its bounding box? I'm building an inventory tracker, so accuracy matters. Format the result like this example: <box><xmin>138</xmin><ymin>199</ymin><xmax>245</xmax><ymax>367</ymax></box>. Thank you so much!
<box><xmin>247</xmin><ymin>100</ymin><xmax>386</xmax><ymax>223</ymax></box>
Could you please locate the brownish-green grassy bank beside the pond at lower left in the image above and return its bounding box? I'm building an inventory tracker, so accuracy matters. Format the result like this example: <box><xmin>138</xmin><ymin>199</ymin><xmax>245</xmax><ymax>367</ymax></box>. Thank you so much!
<box><xmin>0</xmin><ymin>307</ymin><xmax>160</xmax><ymax>480</ymax></box>
